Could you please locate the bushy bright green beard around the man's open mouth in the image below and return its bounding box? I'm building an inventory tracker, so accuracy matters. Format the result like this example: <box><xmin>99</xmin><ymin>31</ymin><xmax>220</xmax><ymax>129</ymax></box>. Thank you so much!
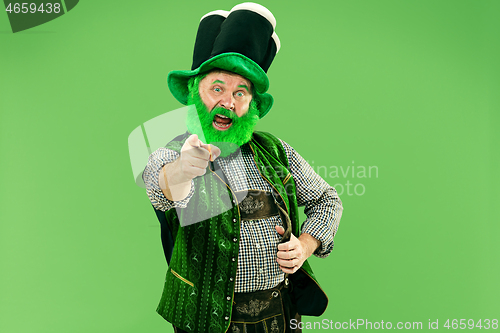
<box><xmin>186</xmin><ymin>89</ymin><xmax>259</xmax><ymax>157</ymax></box>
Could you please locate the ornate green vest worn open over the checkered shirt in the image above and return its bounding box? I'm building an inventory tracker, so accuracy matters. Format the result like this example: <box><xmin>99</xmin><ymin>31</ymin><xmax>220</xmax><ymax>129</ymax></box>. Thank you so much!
<box><xmin>156</xmin><ymin>132</ymin><xmax>328</xmax><ymax>333</ymax></box>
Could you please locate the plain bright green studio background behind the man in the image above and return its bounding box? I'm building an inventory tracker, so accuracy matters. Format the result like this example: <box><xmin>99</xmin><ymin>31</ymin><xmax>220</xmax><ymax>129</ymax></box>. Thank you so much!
<box><xmin>0</xmin><ymin>0</ymin><xmax>500</xmax><ymax>333</ymax></box>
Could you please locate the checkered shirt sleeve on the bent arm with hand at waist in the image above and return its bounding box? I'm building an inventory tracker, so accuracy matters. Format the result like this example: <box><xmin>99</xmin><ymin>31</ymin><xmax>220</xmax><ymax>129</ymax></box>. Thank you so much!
<box><xmin>280</xmin><ymin>140</ymin><xmax>343</xmax><ymax>258</ymax></box>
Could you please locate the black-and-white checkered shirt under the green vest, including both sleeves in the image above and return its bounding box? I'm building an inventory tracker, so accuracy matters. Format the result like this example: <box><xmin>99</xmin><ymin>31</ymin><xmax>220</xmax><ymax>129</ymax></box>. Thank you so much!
<box><xmin>143</xmin><ymin>140</ymin><xmax>342</xmax><ymax>293</ymax></box>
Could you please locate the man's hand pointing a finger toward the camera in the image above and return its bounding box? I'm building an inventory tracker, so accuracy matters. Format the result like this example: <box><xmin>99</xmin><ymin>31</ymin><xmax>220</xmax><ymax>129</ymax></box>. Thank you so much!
<box><xmin>158</xmin><ymin>134</ymin><xmax>220</xmax><ymax>201</ymax></box>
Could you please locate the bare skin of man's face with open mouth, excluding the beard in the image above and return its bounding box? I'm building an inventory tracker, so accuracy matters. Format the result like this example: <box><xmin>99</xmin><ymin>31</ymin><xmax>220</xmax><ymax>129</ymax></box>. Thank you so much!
<box><xmin>199</xmin><ymin>71</ymin><xmax>252</xmax><ymax>127</ymax></box>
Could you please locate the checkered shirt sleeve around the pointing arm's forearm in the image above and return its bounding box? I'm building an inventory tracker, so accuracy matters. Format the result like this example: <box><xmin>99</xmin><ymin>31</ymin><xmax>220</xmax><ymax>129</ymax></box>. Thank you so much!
<box><xmin>142</xmin><ymin>148</ymin><xmax>194</xmax><ymax>212</ymax></box>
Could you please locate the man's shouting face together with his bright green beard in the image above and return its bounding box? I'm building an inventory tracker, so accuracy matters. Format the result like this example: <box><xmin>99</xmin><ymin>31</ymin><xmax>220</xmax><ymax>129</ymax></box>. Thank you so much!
<box><xmin>186</xmin><ymin>71</ymin><xmax>260</xmax><ymax>157</ymax></box>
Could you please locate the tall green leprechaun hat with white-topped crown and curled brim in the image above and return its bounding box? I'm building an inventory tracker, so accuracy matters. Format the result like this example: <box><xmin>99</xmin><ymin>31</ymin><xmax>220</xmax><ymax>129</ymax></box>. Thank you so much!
<box><xmin>167</xmin><ymin>2</ymin><xmax>280</xmax><ymax>118</ymax></box>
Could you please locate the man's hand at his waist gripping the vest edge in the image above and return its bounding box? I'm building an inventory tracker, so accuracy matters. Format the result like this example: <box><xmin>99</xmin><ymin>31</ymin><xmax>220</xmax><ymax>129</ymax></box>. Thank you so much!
<box><xmin>276</xmin><ymin>226</ymin><xmax>321</xmax><ymax>274</ymax></box>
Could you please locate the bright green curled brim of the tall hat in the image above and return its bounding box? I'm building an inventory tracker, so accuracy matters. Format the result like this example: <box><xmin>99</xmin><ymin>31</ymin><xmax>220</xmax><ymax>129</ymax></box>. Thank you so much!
<box><xmin>167</xmin><ymin>53</ymin><xmax>273</xmax><ymax>118</ymax></box>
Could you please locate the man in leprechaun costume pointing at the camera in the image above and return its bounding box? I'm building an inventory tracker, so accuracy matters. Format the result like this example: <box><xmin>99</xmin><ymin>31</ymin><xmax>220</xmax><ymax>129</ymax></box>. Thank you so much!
<box><xmin>143</xmin><ymin>3</ymin><xmax>342</xmax><ymax>332</ymax></box>
